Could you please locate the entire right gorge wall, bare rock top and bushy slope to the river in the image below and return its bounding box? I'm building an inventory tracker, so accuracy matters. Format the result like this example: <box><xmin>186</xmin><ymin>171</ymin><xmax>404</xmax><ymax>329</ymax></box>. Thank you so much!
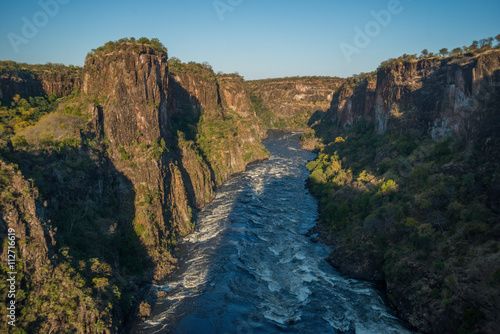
<box><xmin>309</xmin><ymin>50</ymin><xmax>500</xmax><ymax>333</ymax></box>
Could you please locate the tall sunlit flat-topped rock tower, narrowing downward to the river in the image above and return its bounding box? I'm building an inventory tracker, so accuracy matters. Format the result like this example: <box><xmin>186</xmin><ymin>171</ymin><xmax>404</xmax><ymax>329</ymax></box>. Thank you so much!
<box><xmin>82</xmin><ymin>44</ymin><xmax>185</xmax><ymax>279</ymax></box>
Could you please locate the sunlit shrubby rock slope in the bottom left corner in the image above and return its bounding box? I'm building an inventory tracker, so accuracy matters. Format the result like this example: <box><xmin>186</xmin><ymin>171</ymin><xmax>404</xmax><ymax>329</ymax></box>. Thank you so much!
<box><xmin>0</xmin><ymin>161</ymin><xmax>110</xmax><ymax>333</ymax></box>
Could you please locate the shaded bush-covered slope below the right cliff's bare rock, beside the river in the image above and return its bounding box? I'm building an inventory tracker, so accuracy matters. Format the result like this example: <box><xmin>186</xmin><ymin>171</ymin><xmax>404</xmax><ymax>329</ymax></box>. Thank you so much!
<box><xmin>302</xmin><ymin>115</ymin><xmax>500</xmax><ymax>333</ymax></box>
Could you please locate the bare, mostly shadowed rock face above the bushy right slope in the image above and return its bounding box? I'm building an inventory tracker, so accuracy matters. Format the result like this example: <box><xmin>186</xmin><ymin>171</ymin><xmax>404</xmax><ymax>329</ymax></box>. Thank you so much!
<box><xmin>328</xmin><ymin>50</ymin><xmax>500</xmax><ymax>140</ymax></box>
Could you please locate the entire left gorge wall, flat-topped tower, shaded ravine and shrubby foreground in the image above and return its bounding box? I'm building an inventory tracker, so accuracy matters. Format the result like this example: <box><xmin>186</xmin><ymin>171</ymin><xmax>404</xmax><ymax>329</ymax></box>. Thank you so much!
<box><xmin>0</xmin><ymin>41</ymin><xmax>268</xmax><ymax>333</ymax></box>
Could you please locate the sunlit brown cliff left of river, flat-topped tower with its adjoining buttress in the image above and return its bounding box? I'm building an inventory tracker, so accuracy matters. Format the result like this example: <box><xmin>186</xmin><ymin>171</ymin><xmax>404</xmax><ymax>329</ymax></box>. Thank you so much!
<box><xmin>82</xmin><ymin>43</ymin><xmax>266</xmax><ymax>279</ymax></box>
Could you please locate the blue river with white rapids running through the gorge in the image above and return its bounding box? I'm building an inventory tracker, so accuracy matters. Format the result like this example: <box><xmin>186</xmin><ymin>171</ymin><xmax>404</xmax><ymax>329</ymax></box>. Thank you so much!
<box><xmin>135</xmin><ymin>131</ymin><xmax>411</xmax><ymax>334</ymax></box>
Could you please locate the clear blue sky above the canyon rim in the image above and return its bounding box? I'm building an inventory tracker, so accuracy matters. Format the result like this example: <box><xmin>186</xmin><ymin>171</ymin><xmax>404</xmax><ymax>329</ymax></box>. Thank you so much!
<box><xmin>0</xmin><ymin>0</ymin><xmax>500</xmax><ymax>79</ymax></box>
